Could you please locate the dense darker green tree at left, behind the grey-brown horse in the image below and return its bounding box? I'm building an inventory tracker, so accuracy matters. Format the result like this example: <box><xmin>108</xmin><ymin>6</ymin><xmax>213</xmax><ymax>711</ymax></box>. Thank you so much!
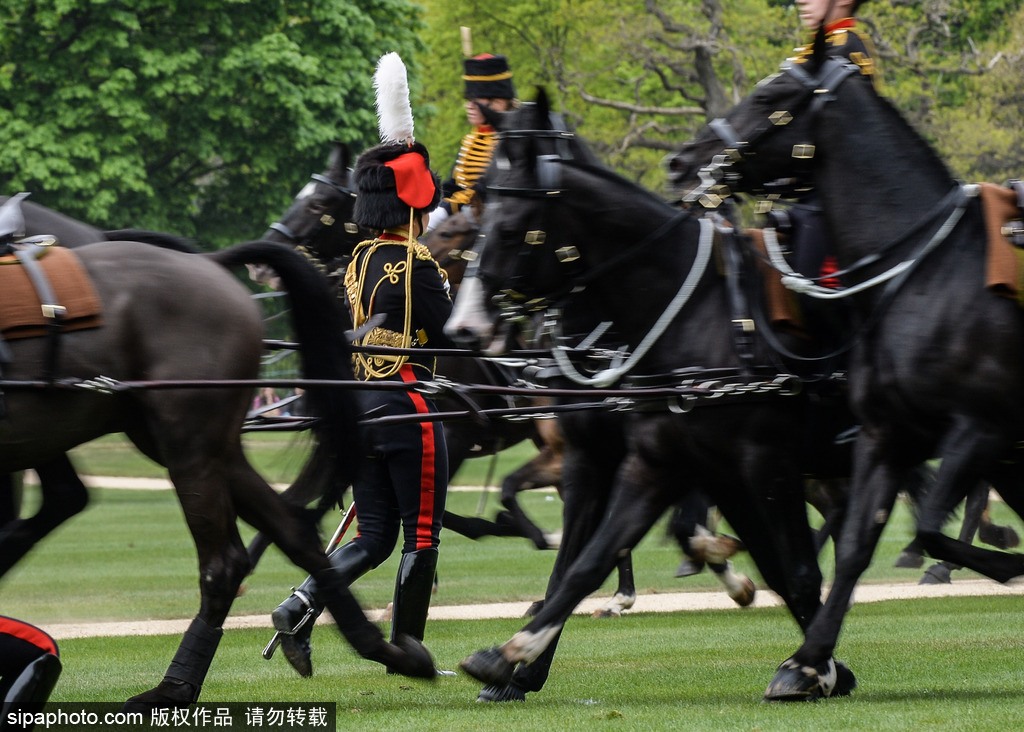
<box><xmin>0</xmin><ymin>0</ymin><xmax>422</xmax><ymax>245</ymax></box>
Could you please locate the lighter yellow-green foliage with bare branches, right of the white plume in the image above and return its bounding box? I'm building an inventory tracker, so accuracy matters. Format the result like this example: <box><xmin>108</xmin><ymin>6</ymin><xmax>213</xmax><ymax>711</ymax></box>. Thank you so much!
<box><xmin>415</xmin><ymin>0</ymin><xmax>1024</xmax><ymax>187</ymax></box>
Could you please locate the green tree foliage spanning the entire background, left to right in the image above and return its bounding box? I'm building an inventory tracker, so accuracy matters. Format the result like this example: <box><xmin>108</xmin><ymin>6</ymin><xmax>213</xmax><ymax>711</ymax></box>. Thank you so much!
<box><xmin>0</xmin><ymin>0</ymin><xmax>1024</xmax><ymax>245</ymax></box>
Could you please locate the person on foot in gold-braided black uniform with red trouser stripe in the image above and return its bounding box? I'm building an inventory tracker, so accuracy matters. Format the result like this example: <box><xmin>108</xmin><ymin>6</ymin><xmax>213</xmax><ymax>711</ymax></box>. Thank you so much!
<box><xmin>272</xmin><ymin>137</ymin><xmax>453</xmax><ymax>676</ymax></box>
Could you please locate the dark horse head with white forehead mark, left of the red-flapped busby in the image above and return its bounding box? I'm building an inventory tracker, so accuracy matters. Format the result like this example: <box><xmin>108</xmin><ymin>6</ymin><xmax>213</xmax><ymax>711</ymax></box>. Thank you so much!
<box><xmin>249</xmin><ymin>142</ymin><xmax>371</xmax><ymax>287</ymax></box>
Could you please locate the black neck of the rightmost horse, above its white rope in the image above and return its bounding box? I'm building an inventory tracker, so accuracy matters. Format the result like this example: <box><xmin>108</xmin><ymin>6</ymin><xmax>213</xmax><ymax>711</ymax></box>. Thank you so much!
<box><xmin>816</xmin><ymin>79</ymin><xmax>953</xmax><ymax>265</ymax></box>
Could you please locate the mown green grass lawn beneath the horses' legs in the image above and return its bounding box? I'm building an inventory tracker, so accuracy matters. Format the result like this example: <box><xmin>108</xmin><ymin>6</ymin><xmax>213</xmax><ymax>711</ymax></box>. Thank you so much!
<box><xmin>8</xmin><ymin>435</ymin><xmax>1024</xmax><ymax>732</ymax></box>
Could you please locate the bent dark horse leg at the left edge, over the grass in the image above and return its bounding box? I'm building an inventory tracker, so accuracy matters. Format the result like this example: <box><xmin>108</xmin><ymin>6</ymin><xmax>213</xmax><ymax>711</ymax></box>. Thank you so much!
<box><xmin>0</xmin><ymin>455</ymin><xmax>89</xmax><ymax>576</ymax></box>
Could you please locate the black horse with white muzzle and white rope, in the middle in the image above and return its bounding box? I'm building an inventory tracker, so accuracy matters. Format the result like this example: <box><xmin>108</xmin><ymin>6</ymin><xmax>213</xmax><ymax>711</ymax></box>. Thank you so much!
<box><xmin>449</xmin><ymin>93</ymin><xmax>855</xmax><ymax>700</ymax></box>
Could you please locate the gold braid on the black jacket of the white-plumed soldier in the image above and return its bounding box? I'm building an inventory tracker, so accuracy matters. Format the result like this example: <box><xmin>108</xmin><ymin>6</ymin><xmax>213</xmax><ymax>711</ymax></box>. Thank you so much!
<box><xmin>345</xmin><ymin>231</ymin><xmax>447</xmax><ymax>381</ymax></box>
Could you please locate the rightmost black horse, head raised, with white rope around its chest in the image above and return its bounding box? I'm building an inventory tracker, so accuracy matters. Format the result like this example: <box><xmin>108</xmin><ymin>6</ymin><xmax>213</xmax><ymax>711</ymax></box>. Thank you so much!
<box><xmin>671</xmin><ymin>38</ymin><xmax>1024</xmax><ymax>699</ymax></box>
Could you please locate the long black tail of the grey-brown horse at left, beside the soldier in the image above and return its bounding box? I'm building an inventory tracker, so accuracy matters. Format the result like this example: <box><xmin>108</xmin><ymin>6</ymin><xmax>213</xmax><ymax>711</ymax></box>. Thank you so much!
<box><xmin>203</xmin><ymin>241</ymin><xmax>362</xmax><ymax>515</ymax></box>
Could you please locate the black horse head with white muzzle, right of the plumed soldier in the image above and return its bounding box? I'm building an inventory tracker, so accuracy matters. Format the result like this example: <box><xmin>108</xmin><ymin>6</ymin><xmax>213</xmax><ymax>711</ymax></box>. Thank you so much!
<box><xmin>446</xmin><ymin>90</ymin><xmax>596</xmax><ymax>352</ymax></box>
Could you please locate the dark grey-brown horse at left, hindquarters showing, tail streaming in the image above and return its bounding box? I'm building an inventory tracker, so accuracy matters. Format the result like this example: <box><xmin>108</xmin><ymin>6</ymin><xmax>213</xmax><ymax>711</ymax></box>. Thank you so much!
<box><xmin>0</xmin><ymin>203</ymin><xmax>434</xmax><ymax>709</ymax></box>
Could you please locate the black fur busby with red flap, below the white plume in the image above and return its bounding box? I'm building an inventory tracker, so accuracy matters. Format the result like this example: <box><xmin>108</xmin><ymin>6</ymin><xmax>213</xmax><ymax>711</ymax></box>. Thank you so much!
<box><xmin>352</xmin><ymin>142</ymin><xmax>441</xmax><ymax>229</ymax></box>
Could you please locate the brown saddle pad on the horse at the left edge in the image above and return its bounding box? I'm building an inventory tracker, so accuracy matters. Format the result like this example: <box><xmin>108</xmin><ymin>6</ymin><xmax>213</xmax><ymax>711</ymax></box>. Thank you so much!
<box><xmin>0</xmin><ymin>247</ymin><xmax>102</xmax><ymax>340</ymax></box>
